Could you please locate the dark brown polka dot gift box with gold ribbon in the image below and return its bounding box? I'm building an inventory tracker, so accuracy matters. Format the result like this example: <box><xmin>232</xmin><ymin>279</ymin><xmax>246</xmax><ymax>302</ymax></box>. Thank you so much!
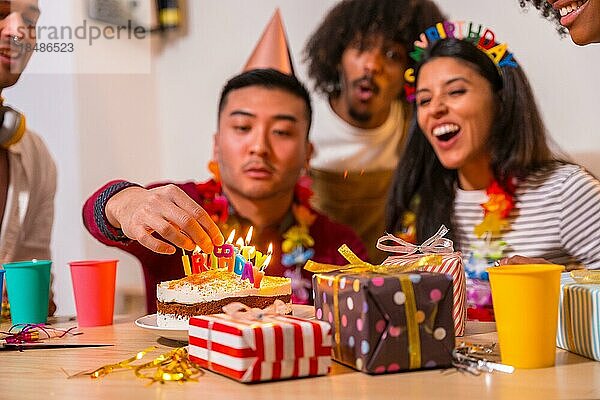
<box><xmin>305</xmin><ymin>245</ymin><xmax>455</xmax><ymax>374</ymax></box>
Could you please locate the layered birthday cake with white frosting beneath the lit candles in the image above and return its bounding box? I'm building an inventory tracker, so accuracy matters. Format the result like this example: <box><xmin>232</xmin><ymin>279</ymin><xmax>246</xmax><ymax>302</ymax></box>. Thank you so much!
<box><xmin>156</xmin><ymin>269</ymin><xmax>292</xmax><ymax>329</ymax></box>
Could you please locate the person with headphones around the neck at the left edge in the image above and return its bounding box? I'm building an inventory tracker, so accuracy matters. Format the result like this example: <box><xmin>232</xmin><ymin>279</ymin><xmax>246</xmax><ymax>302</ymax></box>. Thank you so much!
<box><xmin>0</xmin><ymin>0</ymin><xmax>56</xmax><ymax>315</ymax></box>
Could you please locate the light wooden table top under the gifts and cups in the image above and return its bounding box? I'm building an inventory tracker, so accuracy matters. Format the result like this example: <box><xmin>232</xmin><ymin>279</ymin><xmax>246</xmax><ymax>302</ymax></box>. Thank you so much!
<box><xmin>0</xmin><ymin>320</ymin><xmax>600</xmax><ymax>400</ymax></box>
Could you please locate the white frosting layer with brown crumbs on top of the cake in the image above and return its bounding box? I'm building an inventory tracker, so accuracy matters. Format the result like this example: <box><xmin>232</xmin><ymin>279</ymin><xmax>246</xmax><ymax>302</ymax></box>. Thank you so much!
<box><xmin>156</xmin><ymin>270</ymin><xmax>292</xmax><ymax>304</ymax></box>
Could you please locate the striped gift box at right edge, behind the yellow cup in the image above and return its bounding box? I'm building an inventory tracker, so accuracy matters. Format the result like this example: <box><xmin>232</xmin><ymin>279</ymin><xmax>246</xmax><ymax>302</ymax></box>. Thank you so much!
<box><xmin>556</xmin><ymin>274</ymin><xmax>600</xmax><ymax>361</ymax></box>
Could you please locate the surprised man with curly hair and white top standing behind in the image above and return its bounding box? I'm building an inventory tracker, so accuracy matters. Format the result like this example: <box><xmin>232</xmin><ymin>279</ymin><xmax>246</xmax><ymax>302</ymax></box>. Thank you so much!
<box><xmin>305</xmin><ymin>0</ymin><xmax>443</xmax><ymax>262</ymax></box>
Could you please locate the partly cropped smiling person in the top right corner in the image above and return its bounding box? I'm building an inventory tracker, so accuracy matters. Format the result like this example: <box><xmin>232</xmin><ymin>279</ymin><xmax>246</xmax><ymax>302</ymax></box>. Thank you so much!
<box><xmin>519</xmin><ymin>0</ymin><xmax>600</xmax><ymax>46</ymax></box>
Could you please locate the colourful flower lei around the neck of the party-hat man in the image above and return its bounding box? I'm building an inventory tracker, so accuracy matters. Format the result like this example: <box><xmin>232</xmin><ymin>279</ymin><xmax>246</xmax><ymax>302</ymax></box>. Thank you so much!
<box><xmin>196</xmin><ymin>161</ymin><xmax>317</xmax><ymax>304</ymax></box>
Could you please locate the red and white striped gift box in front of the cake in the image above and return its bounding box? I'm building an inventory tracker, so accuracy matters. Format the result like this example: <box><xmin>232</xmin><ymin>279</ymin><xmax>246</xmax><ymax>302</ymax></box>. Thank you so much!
<box><xmin>189</xmin><ymin>314</ymin><xmax>331</xmax><ymax>382</ymax></box>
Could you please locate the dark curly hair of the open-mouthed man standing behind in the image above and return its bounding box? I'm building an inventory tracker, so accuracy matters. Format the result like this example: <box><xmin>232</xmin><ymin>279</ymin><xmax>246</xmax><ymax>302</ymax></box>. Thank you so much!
<box><xmin>304</xmin><ymin>0</ymin><xmax>444</xmax><ymax>97</ymax></box>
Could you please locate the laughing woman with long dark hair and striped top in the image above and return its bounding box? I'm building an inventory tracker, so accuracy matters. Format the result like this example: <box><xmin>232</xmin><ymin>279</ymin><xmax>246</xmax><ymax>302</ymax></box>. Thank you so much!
<box><xmin>387</xmin><ymin>33</ymin><xmax>600</xmax><ymax>320</ymax></box>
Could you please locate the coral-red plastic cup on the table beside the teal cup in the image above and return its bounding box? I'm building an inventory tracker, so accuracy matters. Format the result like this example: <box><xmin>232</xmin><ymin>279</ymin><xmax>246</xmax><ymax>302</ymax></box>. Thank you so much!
<box><xmin>69</xmin><ymin>260</ymin><xmax>118</xmax><ymax>327</ymax></box>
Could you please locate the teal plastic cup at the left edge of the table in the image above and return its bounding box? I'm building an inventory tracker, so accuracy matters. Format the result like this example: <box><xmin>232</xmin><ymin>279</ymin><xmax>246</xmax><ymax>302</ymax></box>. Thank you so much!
<box><xmin>2</xmin><ymin>260</ymin><xmax>52</xmax><ymax>325</ymax></box>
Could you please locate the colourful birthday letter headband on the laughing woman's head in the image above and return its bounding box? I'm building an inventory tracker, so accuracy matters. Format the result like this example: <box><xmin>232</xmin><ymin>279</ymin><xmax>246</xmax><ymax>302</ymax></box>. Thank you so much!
<box><xmin>404</xmin><ymin>21</ymin><xmax>517</xmax><ymax>102</ymax></box>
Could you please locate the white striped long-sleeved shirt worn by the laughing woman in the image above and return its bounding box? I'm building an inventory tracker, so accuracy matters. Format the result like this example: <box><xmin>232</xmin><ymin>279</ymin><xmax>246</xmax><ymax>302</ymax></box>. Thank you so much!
<box><xmin>454</xmin><ymin>164</ymin><xmax>600</xmax><ymax>268</ymax></box>
